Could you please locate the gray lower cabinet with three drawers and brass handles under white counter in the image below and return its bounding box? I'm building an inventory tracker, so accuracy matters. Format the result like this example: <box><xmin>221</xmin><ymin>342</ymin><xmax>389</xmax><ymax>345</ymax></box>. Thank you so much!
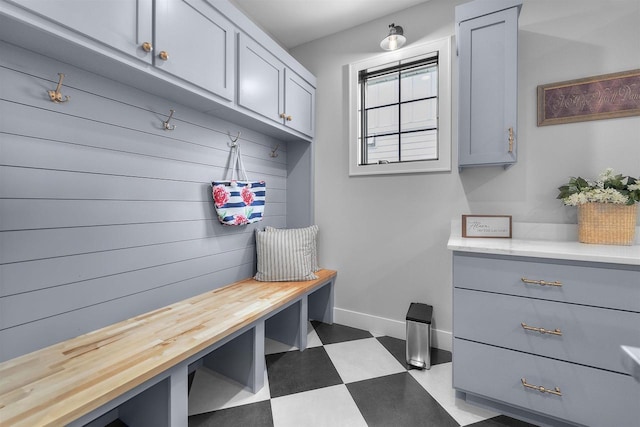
<box><xmin>453</xmin><ymin>252</ymin><xmax>640</xmax><ymax>427</ymax></box>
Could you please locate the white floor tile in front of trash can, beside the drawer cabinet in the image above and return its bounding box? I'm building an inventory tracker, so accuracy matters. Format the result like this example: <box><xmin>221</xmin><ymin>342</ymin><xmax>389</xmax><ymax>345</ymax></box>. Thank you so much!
<box><xmin>409</xmin><ymin>363</ymin><xmax>499</xmax><ymax>426</ymax></box>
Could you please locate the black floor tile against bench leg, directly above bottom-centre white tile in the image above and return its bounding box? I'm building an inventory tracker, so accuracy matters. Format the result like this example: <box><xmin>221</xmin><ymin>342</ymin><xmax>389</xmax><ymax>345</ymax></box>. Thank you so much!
<box><xmin>266</xmin><ymin>347</ymin><xmax>342</xmax><ymax>398</ymax></box>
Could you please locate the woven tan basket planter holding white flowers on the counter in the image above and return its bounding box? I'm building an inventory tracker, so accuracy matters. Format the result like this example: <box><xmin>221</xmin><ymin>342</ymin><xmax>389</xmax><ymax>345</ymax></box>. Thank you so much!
<box><xmin>578</xmin><ymin>203</ymin><xmax>638</xmax><ymax>246</ymax></box>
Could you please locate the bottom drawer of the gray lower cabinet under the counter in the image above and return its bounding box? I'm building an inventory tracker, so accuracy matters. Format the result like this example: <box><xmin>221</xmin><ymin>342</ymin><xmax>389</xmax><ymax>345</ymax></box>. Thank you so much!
<box><xmin>453</xmin><ymin>338</ymin><xmax>640</xmax><ymax>427</ymax></box>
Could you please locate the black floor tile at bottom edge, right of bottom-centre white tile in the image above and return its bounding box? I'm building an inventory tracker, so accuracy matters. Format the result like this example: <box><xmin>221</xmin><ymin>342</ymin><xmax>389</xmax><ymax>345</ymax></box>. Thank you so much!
<box><xmin>347</xmin><ymin>372</ymin><xmax>458</xmax><ymax>427</ymax></box>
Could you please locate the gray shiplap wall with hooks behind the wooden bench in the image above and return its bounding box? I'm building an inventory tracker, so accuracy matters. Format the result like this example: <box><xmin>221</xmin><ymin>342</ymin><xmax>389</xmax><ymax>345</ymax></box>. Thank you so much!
<box><xmin>0</xmin><ymin>43</ymin><xmax>290</xmax><ymax>361</ymax></box>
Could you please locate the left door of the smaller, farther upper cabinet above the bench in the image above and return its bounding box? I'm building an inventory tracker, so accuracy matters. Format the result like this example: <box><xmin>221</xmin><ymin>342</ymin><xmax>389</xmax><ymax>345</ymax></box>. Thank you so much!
<box><xmin>238</xmin><ymin>34</ymin><xmax>285</xmax><ymax>123</ymax></box>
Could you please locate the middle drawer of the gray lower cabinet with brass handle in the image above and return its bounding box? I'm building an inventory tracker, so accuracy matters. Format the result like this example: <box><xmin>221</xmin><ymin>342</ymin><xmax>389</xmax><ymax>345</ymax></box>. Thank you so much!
<box><xmin>454</xmin><ymin>289</ymin><xmax>640</xmax><ymax>373</ymax></box>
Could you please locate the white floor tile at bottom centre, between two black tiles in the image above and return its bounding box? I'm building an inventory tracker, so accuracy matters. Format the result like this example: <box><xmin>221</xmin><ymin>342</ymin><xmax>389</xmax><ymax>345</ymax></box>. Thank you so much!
<box><xmin>271</xmin><ymin>384</ymin><xmax>367</xmax><ymax>427</ymax></box>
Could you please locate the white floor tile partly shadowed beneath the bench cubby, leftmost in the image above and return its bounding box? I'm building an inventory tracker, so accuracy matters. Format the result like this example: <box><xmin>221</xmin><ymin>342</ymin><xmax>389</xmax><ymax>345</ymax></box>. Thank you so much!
<box><xmin>189</xmin><ymin>367</ymin><xmax>271</xmax><ymax>415</ymax></box>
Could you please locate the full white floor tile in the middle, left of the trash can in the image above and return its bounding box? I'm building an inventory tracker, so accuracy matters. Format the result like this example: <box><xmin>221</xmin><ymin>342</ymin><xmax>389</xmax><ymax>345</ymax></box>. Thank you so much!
<box><xmin>324</xmin><ymin>338</ymin><xmax>405</xmax><ymax>383</ymax></box>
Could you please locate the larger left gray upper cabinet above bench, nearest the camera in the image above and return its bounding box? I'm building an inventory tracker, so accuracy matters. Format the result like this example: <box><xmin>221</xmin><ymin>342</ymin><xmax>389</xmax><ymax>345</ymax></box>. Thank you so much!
<box><xmin>1</xmin><ymin>0</ymin><xmax>235</xmax><ymax>101</ymax></box>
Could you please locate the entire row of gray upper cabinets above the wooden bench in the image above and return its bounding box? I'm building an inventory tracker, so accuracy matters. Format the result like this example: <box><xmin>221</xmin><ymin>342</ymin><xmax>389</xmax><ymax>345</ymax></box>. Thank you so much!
<box><xmin>0</xmin><ymin>0</ymin><xmax>315</xmax><ymax>141</ymax></box>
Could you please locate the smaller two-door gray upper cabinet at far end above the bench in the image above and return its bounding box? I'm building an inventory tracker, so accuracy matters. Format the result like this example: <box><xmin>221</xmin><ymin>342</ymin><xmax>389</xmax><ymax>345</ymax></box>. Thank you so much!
<box><xmin>237</xmin><ymin>34</ymin><xmax>315</xmax><ymax>137</ymax></box>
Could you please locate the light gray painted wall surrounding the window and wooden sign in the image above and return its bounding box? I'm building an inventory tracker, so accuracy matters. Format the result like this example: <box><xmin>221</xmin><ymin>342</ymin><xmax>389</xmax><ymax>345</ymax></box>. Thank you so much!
<box><xmin>291</xmin><ymin>0</ymin><xmax>640</xmax><ymax>348</ymax></box>
